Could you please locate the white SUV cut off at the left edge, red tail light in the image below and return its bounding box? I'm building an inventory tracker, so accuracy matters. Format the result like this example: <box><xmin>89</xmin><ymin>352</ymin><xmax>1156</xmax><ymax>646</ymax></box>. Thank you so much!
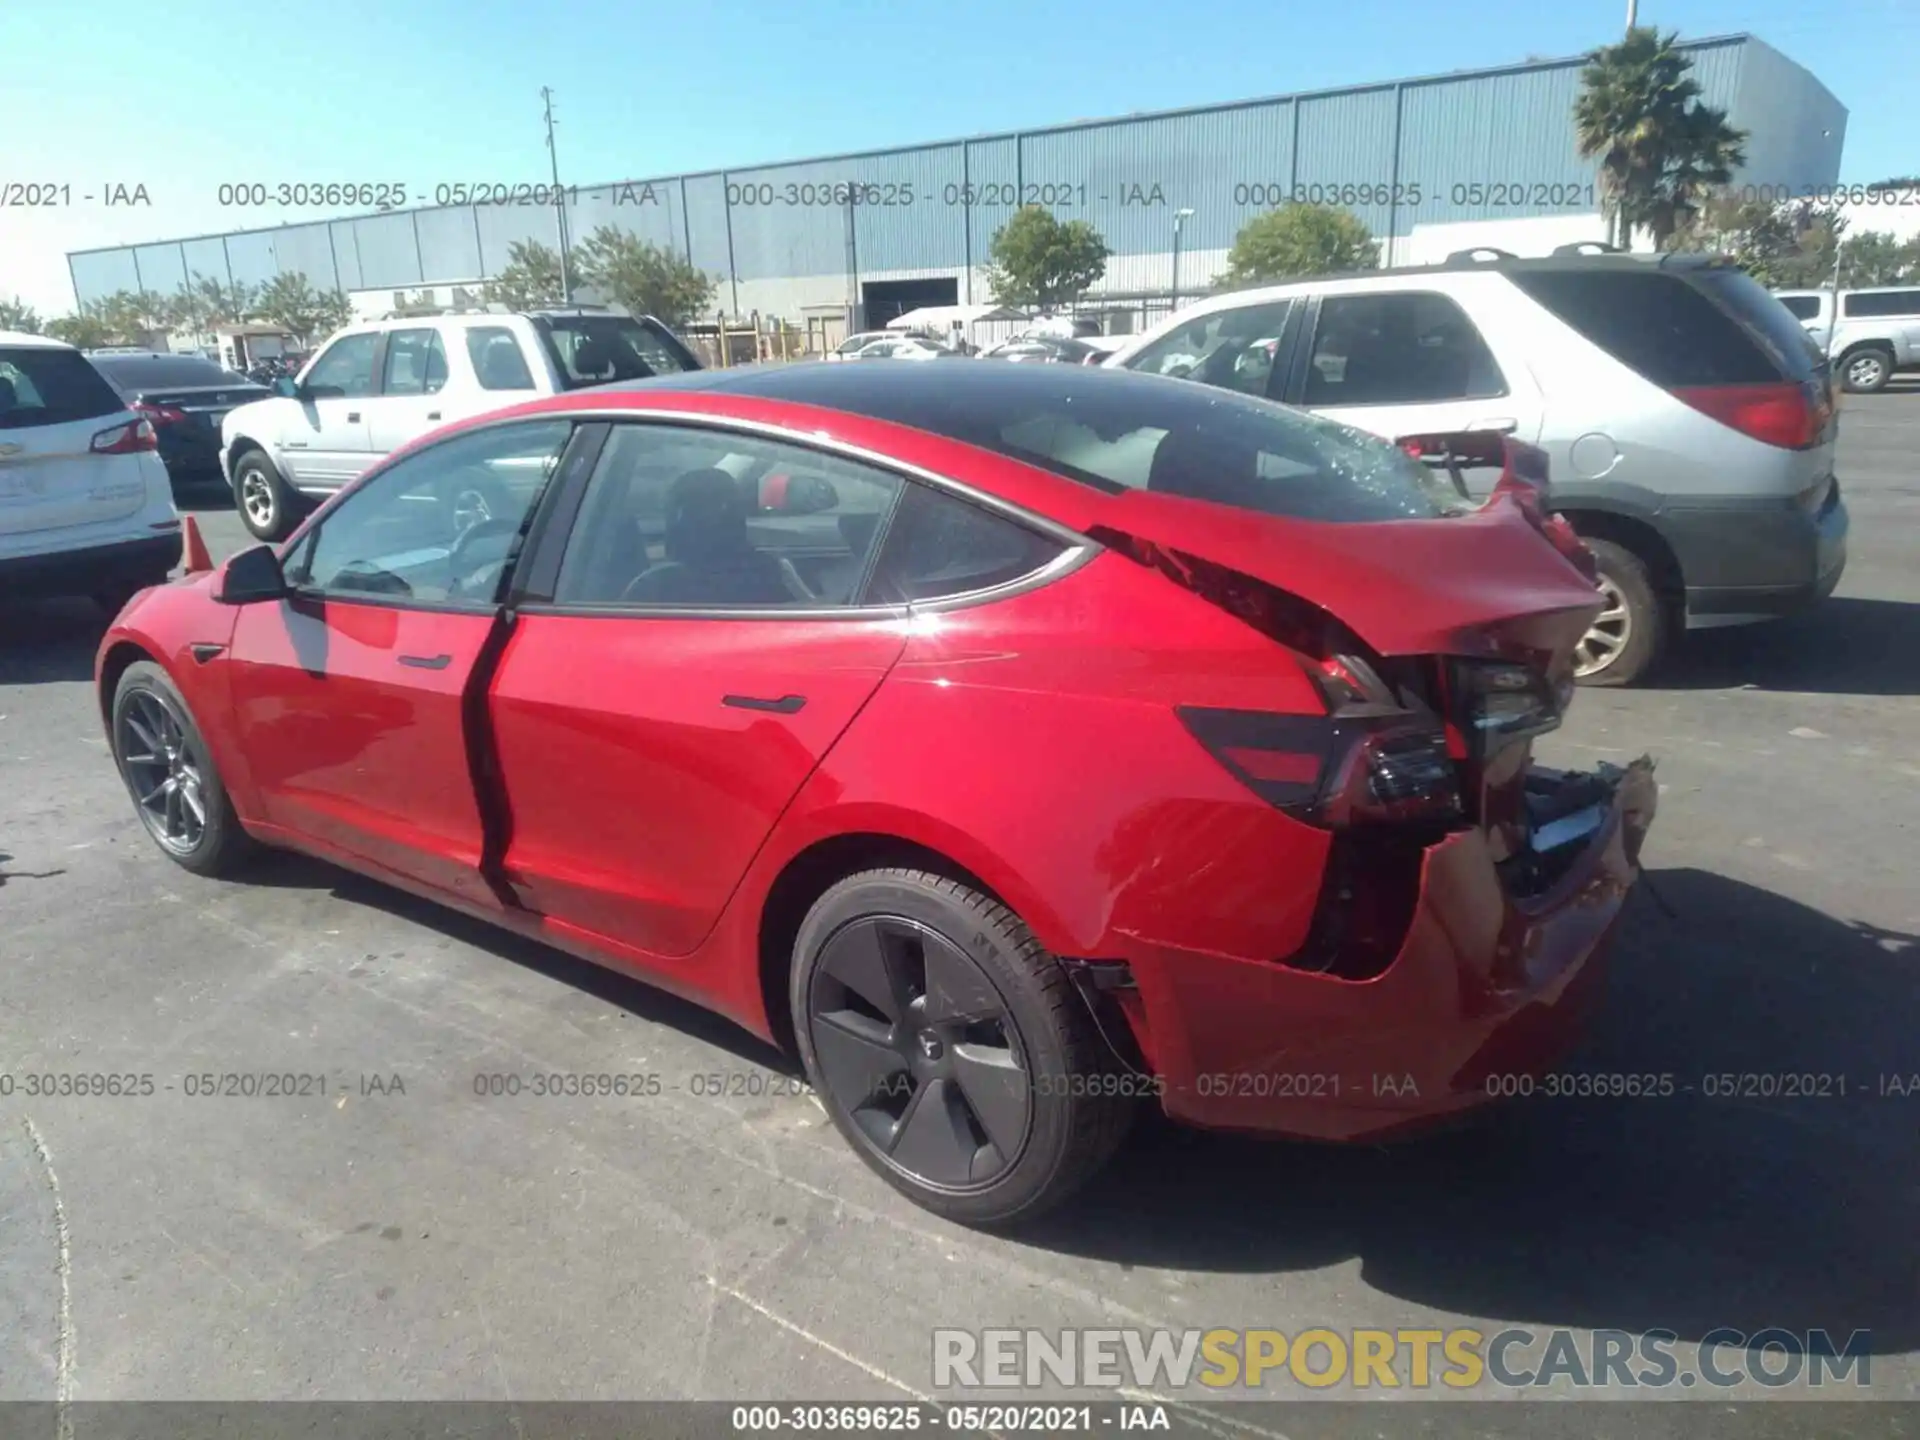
<box><xmin>0</xmin><ymin>330</ymin><xmax>180</xmax><ymax>611</ymax></box>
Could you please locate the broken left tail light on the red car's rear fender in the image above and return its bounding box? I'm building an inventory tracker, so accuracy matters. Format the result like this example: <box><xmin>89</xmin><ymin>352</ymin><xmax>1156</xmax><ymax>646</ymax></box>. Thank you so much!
<box><xmin>1179</xmin><ymin>707</ymin><xmax>1461</xmax><ymax>829</ymax></box>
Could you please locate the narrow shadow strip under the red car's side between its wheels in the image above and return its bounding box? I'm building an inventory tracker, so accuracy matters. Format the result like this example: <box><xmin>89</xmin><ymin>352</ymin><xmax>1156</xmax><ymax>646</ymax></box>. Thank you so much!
<box><xmin>246</xmin><ymin>851</ymin><xmax>803</xmax><ymax>1077</ymax></box>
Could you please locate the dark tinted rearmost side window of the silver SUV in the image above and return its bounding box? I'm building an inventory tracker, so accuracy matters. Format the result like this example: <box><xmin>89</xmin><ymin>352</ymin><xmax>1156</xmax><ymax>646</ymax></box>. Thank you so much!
<box><xmin>1513</xmin><ymin>269</ymin><xmax>1814</xmax><ymax>390</ymax></box>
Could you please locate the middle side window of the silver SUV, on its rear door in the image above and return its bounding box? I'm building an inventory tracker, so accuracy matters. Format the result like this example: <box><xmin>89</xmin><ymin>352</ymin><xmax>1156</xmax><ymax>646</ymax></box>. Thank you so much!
<box><xmin>1304</xmin><ymin>290</ymin><xmax>1507</xmax><ymax>407</ymax></box>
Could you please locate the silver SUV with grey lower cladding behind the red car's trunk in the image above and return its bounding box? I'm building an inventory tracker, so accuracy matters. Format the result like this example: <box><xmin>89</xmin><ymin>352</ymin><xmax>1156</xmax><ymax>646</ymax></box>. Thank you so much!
<box><xmin>1108</xmin><ymin>252</ymin><xmax>1847</xmax><ymax>684</ymax></box>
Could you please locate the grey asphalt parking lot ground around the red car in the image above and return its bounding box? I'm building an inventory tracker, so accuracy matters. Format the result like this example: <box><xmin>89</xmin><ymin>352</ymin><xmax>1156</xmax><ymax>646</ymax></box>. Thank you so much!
<box><xmin>0</xmin><ymin>386</ymin><xmax>1920</xmax><ymax>1436</ymax></box>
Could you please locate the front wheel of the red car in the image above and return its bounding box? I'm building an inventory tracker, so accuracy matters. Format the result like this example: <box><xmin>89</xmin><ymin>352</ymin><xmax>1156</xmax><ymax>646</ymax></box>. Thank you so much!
<box><xmin>108</xmin><ymin>660</ymin><xmax>259</xmax><ymax>876</ymax></box>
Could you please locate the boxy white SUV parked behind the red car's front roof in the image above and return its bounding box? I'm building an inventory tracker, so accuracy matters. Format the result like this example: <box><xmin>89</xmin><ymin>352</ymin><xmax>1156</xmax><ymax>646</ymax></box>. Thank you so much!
<box><xmin>221</xmin><ymin>309</ymin><xmax>701</xmax><ymax>540</ymax></box>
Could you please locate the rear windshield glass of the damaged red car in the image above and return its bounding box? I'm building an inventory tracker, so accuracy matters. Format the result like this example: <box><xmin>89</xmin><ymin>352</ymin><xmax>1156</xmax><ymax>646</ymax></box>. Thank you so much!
<box><xmin>817</xmin><ymin>361</ymin><xmax>1465</xmax><ymax>522</ymax></box>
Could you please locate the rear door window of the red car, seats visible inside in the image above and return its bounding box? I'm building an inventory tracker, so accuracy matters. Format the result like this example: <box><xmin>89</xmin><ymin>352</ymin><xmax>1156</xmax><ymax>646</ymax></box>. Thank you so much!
<box><xmin>553</xmin><ymin>424</ymin><xmax>902</xmax><ymax>609</ymax></box>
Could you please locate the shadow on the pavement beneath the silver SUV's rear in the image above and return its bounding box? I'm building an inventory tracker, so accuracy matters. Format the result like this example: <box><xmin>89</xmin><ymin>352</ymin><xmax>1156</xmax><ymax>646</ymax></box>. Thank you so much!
<box><xmin>1647</xmin><ymin>595</ymin><xmax>1920</xmax><ymax>695</ymax></box>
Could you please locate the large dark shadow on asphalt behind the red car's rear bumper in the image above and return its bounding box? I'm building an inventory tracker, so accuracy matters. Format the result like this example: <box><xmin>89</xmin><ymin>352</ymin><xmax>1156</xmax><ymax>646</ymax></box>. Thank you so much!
<box><xmin>1021</xmin><ymin>870</ymin><xmax>1920</xmax><ymax>1354</ymax></box>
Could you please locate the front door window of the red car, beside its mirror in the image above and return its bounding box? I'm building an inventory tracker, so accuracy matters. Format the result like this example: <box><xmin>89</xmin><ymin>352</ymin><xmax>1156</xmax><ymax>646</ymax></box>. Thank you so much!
<box><xmin>288</xmin><ymin>420</ymin><xmax>572</xmax><ymax>607</ymax></box>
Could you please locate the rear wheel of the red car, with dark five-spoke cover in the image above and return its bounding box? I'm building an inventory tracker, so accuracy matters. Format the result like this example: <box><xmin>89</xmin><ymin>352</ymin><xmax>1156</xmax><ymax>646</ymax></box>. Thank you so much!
<box><xmin>789</xmin><ymin>870</ymin><xmax>1135</xmax><ymax>1227</ymax></box>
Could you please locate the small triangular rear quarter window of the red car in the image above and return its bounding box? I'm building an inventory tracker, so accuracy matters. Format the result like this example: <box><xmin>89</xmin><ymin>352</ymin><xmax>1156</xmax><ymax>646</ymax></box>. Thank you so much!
<box><xmin>868</xmin><ymin>484</ymin><xmax>1062</xmax><ymax>605</ymax></box>
